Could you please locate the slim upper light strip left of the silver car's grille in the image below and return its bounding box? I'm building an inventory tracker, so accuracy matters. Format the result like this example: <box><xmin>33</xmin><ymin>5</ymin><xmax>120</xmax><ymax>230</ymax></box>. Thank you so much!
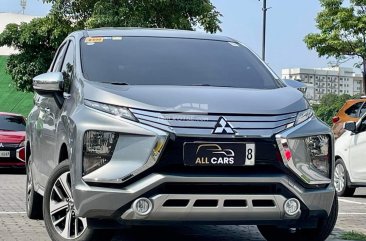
<box><xmin>84</xmin><ymin>100</ymin><xmax>137</xmax><ymax>121</ymax></box>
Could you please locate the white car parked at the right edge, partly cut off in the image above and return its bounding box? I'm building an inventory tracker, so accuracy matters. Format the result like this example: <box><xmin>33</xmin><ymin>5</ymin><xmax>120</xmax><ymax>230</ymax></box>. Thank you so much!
<box><xmin>334</xmin><ymin>115</ymin><xmax>366</xmax><ymax>196</ymax></box>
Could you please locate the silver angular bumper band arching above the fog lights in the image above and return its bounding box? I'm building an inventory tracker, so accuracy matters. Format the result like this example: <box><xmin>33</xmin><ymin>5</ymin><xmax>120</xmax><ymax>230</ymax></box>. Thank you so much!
<box><xmin>74</xmin><ymin>173</ymin><xmax>334</xmax><ymax>220</ymax></box>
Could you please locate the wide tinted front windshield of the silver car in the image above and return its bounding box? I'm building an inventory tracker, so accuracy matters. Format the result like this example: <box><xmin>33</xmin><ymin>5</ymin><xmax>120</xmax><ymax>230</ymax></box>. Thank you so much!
<box><xmin>81</xmin><ymin>37</ymin><xmax>283</xmax><ymax>89</ymax></box>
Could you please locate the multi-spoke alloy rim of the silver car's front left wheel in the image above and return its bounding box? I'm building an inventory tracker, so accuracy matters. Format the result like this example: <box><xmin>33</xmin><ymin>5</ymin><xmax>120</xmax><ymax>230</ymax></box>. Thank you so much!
<box><xmin>50</xmin><ymin>172</ymin><xmax>87</xmax><ymax>239</ymax></box>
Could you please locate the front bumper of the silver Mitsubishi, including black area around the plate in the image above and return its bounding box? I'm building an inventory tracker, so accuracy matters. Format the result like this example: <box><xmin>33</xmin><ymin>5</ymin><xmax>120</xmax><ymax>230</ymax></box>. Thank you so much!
<box><xmin>69</xmin><ymin>108</ymin><xmax>335</xmax><ymax>227</ymax></box>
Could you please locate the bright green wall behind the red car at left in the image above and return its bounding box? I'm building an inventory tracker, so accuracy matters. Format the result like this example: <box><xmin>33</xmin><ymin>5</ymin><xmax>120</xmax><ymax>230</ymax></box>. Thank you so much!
<box><xmin>0</xmin><ymin>56</ymin><xmax>33</xmax><ymax>116</ymax></box>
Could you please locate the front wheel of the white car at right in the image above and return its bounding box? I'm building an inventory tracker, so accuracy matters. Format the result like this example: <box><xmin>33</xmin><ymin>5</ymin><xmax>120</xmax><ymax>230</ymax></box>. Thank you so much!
<box><xmin>334</xmin><ymin>159</ymin><xmax>356</xmax><ymax>197</ymax></box>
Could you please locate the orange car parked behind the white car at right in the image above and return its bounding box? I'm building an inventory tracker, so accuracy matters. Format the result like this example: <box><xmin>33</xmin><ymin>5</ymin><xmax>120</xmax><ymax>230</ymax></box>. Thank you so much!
<box><xmin>332</xmin><ymin>96</ymin><xmax>366</xmax><ymax>139</ymax></box>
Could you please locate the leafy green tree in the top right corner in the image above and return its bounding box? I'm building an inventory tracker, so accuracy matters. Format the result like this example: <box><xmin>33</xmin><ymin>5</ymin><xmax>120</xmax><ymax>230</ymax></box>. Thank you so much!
<box><xmin>304</xmin><ymin>0</ymin><xmax>366</xmax><ymax>93</ymax></box>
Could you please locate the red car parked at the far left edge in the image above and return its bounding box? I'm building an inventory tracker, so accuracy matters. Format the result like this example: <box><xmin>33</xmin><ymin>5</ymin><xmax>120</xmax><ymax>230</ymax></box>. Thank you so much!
<box><xmin>0</xmin><ymin>112</ymin><xmax>26</xmax><ymax>167</ymax></box>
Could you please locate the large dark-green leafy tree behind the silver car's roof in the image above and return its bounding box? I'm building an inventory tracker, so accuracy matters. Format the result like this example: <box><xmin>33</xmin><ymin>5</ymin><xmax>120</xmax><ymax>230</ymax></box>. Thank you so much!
<box><xmin>0</xmin><ymin>0</ymin><xmax>221</xmax><ymax>91</ymax></box>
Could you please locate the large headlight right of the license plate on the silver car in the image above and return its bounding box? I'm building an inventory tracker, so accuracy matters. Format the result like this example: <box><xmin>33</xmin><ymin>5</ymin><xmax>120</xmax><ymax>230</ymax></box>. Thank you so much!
<box><xmin>277</xmin><ymin>135</ymin><xmax>332</xmax><ymax>184</ymax></box>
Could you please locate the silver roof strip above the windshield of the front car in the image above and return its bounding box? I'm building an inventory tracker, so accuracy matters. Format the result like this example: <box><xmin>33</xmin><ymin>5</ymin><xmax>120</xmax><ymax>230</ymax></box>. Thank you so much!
<box><xmin>72</xmin><ymin>28</ymin><xmax>236</xmax><ymax>42</ymax></box>
